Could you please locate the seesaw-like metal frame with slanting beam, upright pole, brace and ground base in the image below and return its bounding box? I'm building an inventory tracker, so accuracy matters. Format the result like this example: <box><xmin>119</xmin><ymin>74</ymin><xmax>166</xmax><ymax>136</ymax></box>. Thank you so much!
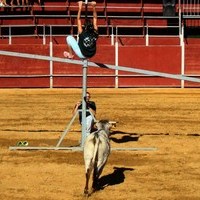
<box><xmin>0</xmin><ymin>50</ymin><xmax>200</xmax><ymax>151</ymax></box>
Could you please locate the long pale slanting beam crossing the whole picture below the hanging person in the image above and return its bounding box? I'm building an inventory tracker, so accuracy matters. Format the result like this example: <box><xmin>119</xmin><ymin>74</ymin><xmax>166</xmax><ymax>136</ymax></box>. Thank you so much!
<box><xmin>0</xmin><ymin>50</ymin><xmax>200</xmax><ymax>83</ymax></box>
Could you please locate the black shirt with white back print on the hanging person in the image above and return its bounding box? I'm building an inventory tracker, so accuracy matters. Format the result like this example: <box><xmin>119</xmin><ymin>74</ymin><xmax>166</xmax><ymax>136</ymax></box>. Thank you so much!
<box><xmin>78</xmin><ymin>30</ymin><xmax>98</xmax><ymax>58</ymax></box>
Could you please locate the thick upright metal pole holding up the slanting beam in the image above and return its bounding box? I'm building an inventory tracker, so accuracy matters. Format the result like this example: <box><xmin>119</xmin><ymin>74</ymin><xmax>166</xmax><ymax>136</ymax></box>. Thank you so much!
<box><xmin>81</xmin><ymin>59</ymin><xmax>88</xmax><ymax>147</ymax></box>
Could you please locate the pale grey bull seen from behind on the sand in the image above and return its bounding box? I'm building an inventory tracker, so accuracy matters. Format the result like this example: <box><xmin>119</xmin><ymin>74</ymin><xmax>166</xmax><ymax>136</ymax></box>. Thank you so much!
<box><xmin>83</xmin><ymin>120</ymin><xmax>112</xmax><ymax>195</ymax></box>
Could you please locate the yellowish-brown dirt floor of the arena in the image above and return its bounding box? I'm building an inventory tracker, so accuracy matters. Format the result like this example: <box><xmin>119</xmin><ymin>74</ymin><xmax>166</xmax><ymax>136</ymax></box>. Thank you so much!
<box><xmin>0</xmin><ymin>88</ymin><xmax>200</xmax><ymax>200</ymax></box>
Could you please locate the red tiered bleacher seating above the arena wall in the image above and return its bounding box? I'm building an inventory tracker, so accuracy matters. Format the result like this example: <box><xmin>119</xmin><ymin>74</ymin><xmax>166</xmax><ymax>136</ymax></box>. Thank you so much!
<box><xmin>0</xmin><ymin>0</ymin><xmax>200</xmax><ymax>44</ymax></box>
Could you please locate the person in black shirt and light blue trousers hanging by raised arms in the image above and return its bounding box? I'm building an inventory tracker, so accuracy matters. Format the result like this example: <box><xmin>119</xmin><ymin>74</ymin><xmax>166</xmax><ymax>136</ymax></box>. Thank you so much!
<box><xmin>64</xmin><ymin>1</ymin><xmax>98</xmax><ymax>59</ymax></box>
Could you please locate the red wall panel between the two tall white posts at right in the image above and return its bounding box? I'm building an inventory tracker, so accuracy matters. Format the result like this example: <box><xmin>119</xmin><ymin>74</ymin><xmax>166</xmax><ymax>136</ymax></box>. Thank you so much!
<box><xmin>119</xmin><ymin>46</ymin><xmax>181</xmax><ymax>87</ymax></box>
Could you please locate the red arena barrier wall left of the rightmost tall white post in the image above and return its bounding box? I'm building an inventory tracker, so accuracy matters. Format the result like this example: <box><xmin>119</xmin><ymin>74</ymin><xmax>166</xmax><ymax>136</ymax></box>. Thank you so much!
<box><xmin>0</xmin><ymin>45</ymin><xmax>181</xmax><ymax>88</ymax></box>
